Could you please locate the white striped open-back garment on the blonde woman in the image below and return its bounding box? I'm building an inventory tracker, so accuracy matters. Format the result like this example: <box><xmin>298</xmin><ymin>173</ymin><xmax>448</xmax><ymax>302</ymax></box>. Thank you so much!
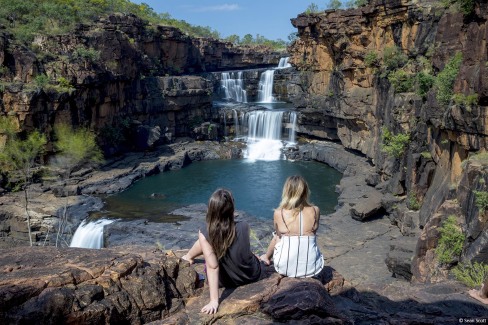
<box><xmin>273</xmin><ymin>211</ymin><xmax>324</xmax><ymax>278</ymax></box>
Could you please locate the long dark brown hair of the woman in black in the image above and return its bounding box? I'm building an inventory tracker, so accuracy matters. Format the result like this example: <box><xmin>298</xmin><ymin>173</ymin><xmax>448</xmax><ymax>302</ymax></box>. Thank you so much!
<box><xmin>207</xmin><ymin>189</ymin><xmax>236</xmax><ymax>260</ymax></box>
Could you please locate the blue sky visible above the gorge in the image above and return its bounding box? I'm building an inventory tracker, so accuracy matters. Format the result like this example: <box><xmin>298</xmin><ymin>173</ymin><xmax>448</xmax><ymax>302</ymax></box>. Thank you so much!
<box><xmin>132</xmin><ymin>0</ymin><xmax>313</xmax><ymax>41</ymax></box>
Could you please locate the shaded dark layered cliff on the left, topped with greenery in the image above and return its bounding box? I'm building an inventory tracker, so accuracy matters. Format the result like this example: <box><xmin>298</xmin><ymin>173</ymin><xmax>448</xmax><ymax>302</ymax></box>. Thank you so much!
<box><xmin>0</xmin><ymin>14</ymin><xmax>281</xmax><ymax>149</ymax></box>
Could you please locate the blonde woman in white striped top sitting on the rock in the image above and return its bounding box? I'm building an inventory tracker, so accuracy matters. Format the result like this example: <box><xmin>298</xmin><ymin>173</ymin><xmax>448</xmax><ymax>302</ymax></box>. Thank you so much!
<box><xmin>260</xmin><ymin>175</ymin><xmax>324</xmax><ymax>278</ymax></box>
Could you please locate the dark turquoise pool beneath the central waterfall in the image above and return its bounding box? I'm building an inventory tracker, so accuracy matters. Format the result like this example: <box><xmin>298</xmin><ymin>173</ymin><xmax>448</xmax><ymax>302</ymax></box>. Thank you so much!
<box><xmin>98</xmin><ymin>159</ymin><xmax>341</xmax><ymax>222</ymax></box>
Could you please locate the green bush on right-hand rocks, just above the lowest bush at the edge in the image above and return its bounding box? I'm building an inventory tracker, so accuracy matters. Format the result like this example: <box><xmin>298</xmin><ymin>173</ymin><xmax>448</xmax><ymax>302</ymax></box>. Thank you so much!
<box><xmin>435</xmin><ymin>215</ymin><xmax>465</xmax><ymax>264</ymax></box>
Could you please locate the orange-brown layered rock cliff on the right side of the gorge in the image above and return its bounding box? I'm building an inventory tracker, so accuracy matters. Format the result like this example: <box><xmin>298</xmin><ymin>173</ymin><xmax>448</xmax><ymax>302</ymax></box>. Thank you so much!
<box><xmin>287</xmin><ymin>0</ymin><xmax>488</xmax><ymax>281</ymax></box>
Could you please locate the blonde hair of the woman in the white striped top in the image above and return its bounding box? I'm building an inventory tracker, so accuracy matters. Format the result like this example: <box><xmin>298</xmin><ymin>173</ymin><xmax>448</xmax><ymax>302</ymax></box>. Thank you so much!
<box><xmin>278</xmin><ymin>175</ymin><xmax>312</xmax><ymax>215</ymax></box>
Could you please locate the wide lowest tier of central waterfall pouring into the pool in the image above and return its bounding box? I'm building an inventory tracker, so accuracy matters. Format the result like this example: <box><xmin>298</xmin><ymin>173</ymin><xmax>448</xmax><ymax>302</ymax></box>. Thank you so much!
<box><xmin>243</xmin><ymin>110</ymin><xmax>296</xmax><ymax>160</ymax></box>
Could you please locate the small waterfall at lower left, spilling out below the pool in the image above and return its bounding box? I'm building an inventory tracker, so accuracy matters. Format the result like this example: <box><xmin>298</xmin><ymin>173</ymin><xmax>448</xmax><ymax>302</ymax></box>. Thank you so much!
<box><xmin>69</xmin><ymin>219</ymin><xmax>115</xmax><ymax>248</ymax></box>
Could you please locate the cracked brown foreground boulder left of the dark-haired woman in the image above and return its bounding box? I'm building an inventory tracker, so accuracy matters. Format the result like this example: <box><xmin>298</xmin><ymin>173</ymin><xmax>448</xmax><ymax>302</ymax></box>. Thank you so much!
<box><xmin>0</xmin><ymin>247</ymin><xmax>199</xmax><ymax>324</ymax></box>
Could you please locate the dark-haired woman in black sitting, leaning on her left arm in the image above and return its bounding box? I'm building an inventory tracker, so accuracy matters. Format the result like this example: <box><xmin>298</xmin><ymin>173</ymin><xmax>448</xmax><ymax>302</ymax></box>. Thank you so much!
<box><xmin>182</xmin><ymin>189</ymin><xmax>261</xmax><ymax>314</ymax></box>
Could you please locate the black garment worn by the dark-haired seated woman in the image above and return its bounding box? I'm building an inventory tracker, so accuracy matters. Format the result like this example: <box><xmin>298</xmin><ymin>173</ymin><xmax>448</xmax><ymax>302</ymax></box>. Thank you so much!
<box><xmin>202</xmin><ymin>221</ymin><xmax>261</xmax><ymax>288</ymax></box>
